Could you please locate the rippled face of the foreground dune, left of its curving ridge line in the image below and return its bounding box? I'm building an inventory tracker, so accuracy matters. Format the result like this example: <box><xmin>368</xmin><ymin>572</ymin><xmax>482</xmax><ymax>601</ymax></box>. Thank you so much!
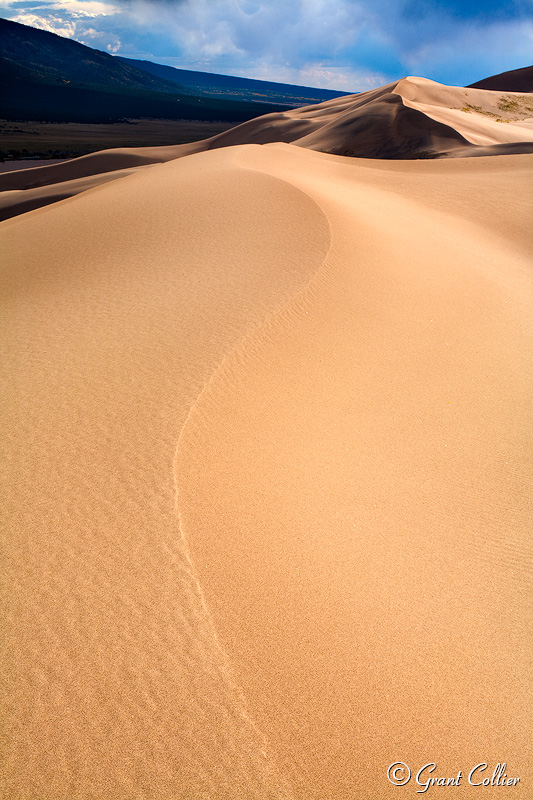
<box><xmin>0</xmin><ymin>145</ymin><xmax>330</xmax><ymax>800</ymax></box>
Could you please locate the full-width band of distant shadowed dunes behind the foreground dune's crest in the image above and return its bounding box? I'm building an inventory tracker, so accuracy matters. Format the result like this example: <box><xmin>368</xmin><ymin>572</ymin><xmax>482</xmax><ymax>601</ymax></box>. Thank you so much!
<box><xmin>0</xmin><ymin>77</ymin><xmax>533</xmax><ymax>219</ymax></box>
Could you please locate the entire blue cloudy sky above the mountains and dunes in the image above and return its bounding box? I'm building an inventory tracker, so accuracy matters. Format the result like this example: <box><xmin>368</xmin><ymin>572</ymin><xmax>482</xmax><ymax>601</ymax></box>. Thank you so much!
<box><xmin>0</xmin><ymin>0</ymin><xmax>533</xmax><ymax>92</ymax></box>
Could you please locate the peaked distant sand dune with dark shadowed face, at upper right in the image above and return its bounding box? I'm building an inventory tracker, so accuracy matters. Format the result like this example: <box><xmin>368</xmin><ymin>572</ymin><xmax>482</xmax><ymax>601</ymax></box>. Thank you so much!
<box><xmin>209</xmin><ymin>78</ymin><xmax>533</xmax><ymax>159</ymax></box>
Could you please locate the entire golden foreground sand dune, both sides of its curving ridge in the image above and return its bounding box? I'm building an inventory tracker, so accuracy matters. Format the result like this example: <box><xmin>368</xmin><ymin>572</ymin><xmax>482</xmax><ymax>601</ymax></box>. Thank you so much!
<box><xmin>0</xmin><ymin>76</ymin><xmax>533</xmax><ymax>800</ymax></box>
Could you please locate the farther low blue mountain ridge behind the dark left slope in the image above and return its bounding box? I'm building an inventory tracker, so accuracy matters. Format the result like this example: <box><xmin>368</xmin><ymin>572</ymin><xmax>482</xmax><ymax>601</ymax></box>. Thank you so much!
<box><xmin>114</xmin><ymin>56</ymin><xmax>348</xmax><ymax>106</ymax></box>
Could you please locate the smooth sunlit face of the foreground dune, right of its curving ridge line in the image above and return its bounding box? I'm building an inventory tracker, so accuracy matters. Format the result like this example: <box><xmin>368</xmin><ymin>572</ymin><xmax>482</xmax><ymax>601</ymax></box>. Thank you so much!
<box><xmin>176</xmin><ymin>146</ymin><xmax>533</xmax><ymax>800</ymax></box>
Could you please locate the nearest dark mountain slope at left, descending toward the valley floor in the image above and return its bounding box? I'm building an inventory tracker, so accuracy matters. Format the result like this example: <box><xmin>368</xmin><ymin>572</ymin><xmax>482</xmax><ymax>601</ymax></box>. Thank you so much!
<box><xmin>0</xmin><ymin>19</ymin><xmax>288</xmax><ymax>122</ymax></box>
